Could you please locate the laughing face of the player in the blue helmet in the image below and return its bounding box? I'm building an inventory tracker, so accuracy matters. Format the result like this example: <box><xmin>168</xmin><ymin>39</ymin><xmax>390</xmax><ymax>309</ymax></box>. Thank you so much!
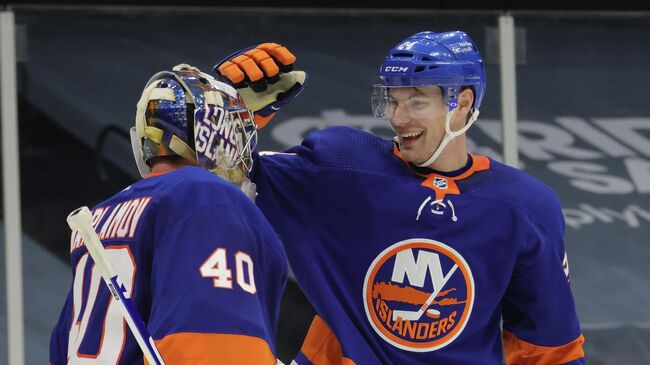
<box><xmin>389</xmin><ymin>86</ymin><xmax>447</xmax><ymax>164</ymax></box>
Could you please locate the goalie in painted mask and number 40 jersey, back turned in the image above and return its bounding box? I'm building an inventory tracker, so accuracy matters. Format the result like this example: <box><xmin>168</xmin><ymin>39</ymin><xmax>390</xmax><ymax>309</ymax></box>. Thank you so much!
<box><xmin>50</xmin><ymin>65</ymin><xmax>287</xmax><ymax>365</ymax></box>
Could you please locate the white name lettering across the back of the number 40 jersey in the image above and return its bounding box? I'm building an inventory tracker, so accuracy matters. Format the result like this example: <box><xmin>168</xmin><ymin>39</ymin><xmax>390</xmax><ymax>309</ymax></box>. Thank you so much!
<box><xmin>70</xmin><ymin>197</ymin><xmax>151</xmax><ymax>252</ymax></box>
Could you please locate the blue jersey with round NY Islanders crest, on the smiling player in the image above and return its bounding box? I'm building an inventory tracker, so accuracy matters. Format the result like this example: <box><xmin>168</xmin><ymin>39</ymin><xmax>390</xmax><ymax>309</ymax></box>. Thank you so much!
<box><xmin>254</xmin><ymin>127</ymin><xmax>584</xmax><ymax>365</ymax></box>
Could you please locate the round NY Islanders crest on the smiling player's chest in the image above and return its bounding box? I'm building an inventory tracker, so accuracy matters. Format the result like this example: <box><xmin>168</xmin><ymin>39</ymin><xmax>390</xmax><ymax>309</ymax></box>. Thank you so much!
<box><xmin>363</xmin><ymin>239</ymin><xmax>474</xmax><ymax>352</ymax></box>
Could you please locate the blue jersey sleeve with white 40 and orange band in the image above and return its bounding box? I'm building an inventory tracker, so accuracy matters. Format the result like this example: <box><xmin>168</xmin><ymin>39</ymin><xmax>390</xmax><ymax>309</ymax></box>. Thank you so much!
<box><xmin>148</xmin><ymin>204</ymin><xmax>286</xmax><ymax>365</ymax></box>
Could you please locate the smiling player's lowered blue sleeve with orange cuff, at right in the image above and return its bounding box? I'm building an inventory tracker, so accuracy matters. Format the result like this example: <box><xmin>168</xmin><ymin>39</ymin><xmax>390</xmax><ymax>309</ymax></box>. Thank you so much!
<box><xmin>503</xmin><ymin>191</ymin><xmax>585</xmax><ymax>365</ymax></box>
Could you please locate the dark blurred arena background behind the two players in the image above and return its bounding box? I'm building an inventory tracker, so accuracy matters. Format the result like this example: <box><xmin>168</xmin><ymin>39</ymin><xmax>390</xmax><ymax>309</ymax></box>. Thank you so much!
<box><xmin>0</xmin><ymin>1</ymin><xmax>650</xmax><ymax>365</ymax></box>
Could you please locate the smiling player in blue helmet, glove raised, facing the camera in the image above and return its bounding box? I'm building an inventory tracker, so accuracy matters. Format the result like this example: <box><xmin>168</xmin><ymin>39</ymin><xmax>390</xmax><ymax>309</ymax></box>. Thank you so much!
<box><xmin>214</xmin><ymin>31</ymin><xmax>585</xmax><ymax>365</ymax></box>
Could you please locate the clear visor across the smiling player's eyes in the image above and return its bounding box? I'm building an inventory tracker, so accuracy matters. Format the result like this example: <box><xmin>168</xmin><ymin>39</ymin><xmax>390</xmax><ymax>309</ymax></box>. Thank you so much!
<box><xmin>371</xmin><ymin>85</ymin><xmax>457</xmax><ymax>119</ymax></box>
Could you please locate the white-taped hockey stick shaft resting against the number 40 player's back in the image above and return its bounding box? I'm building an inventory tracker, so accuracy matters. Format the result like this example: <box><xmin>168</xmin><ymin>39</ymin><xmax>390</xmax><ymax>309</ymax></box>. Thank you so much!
<box><xmin>67</xmin><ymin>207</ymin><xmax>165</xmax><ymax>365</ymax></box>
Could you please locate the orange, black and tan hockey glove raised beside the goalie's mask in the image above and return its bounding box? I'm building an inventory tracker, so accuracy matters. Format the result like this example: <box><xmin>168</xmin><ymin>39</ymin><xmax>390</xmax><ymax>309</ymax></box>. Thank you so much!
<box><xmin>212</xmin><ymin>43</ymin><xmax>307</xmax><ymax>128</ymax></box>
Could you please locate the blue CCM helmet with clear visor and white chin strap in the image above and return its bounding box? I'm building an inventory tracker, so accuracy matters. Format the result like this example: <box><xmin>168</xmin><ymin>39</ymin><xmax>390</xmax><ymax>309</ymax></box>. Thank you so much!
<box><xmin>371</xmin><ymin>31</ymin><xmax>485</xmax><ymax>167</ymax></box>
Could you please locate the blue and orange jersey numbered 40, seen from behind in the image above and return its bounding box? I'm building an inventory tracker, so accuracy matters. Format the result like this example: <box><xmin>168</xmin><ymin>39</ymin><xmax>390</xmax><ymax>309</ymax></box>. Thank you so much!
<box><xmin>50</xmin><ymin>167</ymin><xmax>287</xmax><ymax>365</ymax></box>
